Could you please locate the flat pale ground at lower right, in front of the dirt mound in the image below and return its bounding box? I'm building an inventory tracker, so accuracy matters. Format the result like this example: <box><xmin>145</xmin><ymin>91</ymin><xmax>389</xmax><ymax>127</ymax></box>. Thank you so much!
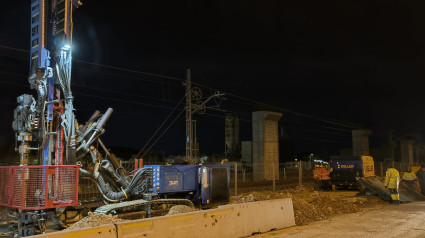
<box><xmin>252</xmin><ymin>202</ymin><xmax>425</xmax><ymax>238</ymax></box>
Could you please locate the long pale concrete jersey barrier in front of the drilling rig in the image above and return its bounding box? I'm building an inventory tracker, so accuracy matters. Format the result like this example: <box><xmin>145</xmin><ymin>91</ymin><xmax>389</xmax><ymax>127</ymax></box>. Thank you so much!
<box><xmin>34</xmin><ymin>198</ymin><xmax>295</xmax><ymax>238</ymax></box>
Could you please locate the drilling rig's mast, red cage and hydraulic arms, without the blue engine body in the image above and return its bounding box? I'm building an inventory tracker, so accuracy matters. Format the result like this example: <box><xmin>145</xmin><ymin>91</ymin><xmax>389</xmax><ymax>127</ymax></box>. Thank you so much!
<box><xmin>0</xmin><ymin>0</ymin><xmax>156</xmax><ymax>236</ymax></box>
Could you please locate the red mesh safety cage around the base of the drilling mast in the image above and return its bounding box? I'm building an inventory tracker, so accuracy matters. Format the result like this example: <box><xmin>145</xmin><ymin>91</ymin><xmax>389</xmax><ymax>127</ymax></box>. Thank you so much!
<box><xmin>0</xmin><ymin>165</ymin><xmax>80</xmax><ymax>210</ymax></box>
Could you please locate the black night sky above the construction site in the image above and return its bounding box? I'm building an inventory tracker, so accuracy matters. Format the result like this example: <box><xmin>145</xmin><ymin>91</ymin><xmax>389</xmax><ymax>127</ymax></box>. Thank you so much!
<box><xmin>0</xmin><ymin>0</ymin><xmax>425</xmax><ymax>158</ymax></box>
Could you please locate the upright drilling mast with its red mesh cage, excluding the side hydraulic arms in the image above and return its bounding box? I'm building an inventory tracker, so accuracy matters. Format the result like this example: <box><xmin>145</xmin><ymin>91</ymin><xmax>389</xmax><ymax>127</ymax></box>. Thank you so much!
<box><xmin>0</xmin><ymin>0</ymin><xmax>81</xmax><ymax>236</ymax></box>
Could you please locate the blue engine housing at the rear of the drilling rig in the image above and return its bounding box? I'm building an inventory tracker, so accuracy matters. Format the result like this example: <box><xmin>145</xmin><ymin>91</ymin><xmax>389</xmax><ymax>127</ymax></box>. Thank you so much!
<box><xmin>145</xmin><ymin>164</ymin><xmax>230</xmax><ymax>205</ymax></box>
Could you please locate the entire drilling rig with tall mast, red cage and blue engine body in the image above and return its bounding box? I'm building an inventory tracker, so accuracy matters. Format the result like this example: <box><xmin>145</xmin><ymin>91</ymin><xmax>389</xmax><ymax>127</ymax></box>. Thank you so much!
<box><xmin>0</xmin><ymin>0</ymin><xmax>230</xmax><ymax>236</ymax></box>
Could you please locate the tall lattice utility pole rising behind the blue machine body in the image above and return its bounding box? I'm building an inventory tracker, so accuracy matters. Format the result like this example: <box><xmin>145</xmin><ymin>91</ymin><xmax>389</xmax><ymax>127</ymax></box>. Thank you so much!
<box><xmin>186</xmin><ymin>69</ymin><xmax>193</xmax><ymax>160</ymax></box>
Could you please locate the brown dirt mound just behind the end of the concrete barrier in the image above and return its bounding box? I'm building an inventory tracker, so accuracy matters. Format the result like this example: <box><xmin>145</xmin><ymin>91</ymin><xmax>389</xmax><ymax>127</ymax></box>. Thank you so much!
<box><xmin>230</xmin><ymin>187</ymin><xmax>386</xmax><ymax>225</ymax></box>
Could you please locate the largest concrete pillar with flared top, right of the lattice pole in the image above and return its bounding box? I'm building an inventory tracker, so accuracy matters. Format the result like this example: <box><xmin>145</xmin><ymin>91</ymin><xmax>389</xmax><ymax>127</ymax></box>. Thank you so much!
<box><xmin>252</xmin><ymin>111</ymin><xmax>282</xmax><ymax>181</ymax></box>
